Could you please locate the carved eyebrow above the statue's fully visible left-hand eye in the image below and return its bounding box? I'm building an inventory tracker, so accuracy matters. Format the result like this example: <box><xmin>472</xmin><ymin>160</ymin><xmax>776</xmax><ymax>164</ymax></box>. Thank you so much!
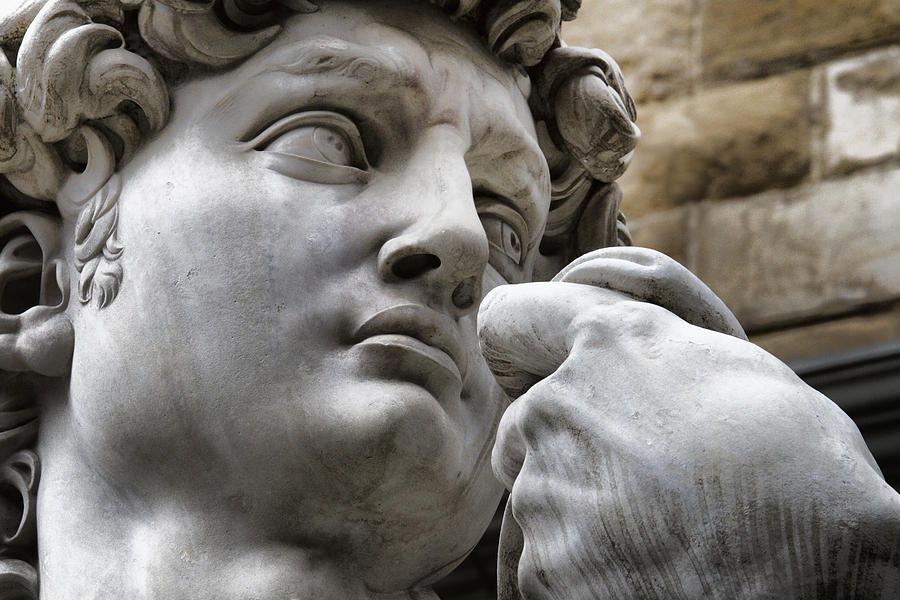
<box><xmin>207</xmin><ymin>35</ymin><xmax>423</xmax><ymax>120</ymax></box>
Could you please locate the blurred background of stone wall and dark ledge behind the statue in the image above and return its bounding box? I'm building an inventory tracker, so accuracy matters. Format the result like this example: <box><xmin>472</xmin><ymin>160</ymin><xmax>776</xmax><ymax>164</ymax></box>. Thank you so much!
<box><xmin>437</xmin><ymin>0</ymin><xmax>900</xmax><ymax>600</ymax></box>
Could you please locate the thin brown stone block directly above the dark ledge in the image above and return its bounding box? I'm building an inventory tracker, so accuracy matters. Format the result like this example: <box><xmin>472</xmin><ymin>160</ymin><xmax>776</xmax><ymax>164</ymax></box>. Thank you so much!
<box><xmin>750</xmin><ymin>306</ymin><xmax>900</xmax><ymax>361</ymax></box>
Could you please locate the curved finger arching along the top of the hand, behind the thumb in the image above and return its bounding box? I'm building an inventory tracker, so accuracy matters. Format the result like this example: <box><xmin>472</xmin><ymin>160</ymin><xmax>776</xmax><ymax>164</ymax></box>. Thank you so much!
<box><xmin>553</xmin><ymin>246</ymin><xmax>747</xmax><ymax>340</ymax></box>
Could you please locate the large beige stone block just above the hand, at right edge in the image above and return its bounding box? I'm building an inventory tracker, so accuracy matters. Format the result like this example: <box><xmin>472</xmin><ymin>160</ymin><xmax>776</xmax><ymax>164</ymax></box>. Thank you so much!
<box><xmin>688</xmin><ymin>169</ymin><xmax>900</xmax><ymax>332</ymax></box>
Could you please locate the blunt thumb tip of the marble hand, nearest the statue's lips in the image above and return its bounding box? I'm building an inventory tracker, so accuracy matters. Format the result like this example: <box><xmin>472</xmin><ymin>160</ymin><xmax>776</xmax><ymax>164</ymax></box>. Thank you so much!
<box><xmin>478</xmin><ymin>283</ymin><xmax>629</xmax><ymax>398</ymax></box>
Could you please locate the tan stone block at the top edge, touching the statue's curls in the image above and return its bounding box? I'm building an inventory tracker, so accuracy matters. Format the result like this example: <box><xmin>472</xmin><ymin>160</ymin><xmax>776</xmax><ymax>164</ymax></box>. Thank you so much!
<box><xmin>563</xmin><ymin>0</ymin><xmax>693</xmax><ymax>102</ymax></box>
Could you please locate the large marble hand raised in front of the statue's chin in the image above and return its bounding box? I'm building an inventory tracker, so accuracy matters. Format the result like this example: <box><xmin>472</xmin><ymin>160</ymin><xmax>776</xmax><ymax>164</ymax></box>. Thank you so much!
<box><xmin>479</xmin><ymin>248</ymin><xmax>900</xmax><ymax>599</ymax></box>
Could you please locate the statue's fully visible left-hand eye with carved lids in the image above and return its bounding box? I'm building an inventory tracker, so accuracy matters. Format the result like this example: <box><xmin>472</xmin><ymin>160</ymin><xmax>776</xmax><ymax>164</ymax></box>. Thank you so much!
<box><xmin>246</xmin><ymin>110</ymin><xmax>371</xmax><ymax>184</ymax></box>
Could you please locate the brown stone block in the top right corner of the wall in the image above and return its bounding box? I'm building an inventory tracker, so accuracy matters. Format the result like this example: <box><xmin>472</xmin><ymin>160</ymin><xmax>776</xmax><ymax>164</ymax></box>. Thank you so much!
<box><xmin>700</xmin><ymin>0</ymin><xmax>900</xmax><ymax>79</ymax></box>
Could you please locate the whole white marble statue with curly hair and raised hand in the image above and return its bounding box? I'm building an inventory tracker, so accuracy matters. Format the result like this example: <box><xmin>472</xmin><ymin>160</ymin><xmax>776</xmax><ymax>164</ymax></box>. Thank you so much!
<box><xmin>0</xmin><ymin>0</ymin><xmax>900</xmax><ymax>600</ymax></box>
